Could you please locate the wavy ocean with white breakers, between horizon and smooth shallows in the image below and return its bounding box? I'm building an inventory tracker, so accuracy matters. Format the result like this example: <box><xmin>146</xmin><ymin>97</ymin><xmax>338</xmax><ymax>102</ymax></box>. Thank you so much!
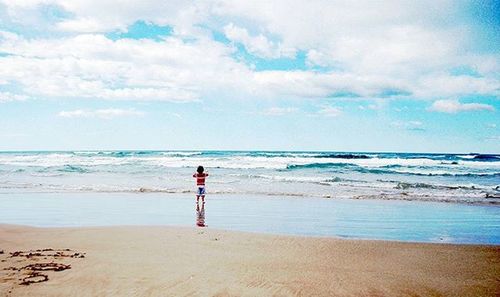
<box><xmin>0</xmin><ymin>151</ymin><xmax>500</xmax><ymax>204</ymax></box>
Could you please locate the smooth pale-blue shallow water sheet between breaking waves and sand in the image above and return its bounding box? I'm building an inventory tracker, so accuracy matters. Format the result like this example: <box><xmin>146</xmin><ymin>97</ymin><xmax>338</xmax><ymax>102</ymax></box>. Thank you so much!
<box><xmin>0</xmin><ymin>193</ymin><xmax>500</xmax><ymax>245</ymax></box>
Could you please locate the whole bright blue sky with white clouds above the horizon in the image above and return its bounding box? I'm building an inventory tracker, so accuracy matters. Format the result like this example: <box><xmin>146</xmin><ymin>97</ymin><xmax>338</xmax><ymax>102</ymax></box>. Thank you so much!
<box><xmin>0</xmin><ymin>0</ymin><xmax>500</xmax><ymax>153</ymax></box>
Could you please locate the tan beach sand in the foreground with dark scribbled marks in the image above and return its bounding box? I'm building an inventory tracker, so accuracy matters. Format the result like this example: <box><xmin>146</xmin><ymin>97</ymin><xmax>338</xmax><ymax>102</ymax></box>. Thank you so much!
<box><xmin>0</xmin><ymin>225</ymin><xmax>500</xmax><ymax>296</ymax></box>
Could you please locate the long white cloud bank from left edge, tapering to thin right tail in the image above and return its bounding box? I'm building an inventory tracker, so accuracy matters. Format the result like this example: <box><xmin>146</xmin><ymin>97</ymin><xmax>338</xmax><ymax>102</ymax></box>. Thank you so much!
<box><xmin>0</xmin><ymin>32</ymin><xmax>426</xmax><ymax>102</ymax></box>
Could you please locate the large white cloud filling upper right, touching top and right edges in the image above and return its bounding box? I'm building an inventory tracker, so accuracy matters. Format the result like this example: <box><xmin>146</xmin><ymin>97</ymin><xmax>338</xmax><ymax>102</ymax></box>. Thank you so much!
<box><xmin>215</xmin><ymin>0</ymin><xmax>500</xmax><ymax>99</ymax></box>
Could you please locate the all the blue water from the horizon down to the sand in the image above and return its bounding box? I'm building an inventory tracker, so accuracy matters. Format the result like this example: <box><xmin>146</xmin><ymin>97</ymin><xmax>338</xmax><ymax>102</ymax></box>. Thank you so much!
<box><xmin>0</xmin><ymin>151</ymin><xmax>500</xmax><ymax>244</ymax></box>
